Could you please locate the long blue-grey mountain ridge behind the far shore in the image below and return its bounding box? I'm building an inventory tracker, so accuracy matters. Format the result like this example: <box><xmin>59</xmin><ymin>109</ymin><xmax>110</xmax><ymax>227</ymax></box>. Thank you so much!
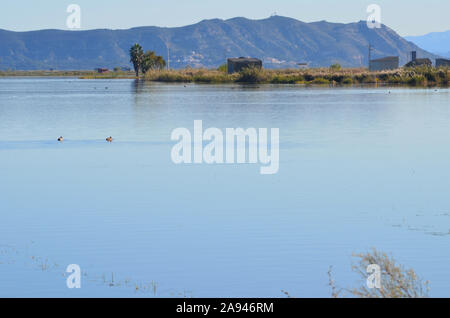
<box><xmin>0</xmin><ymin>16</ymin><xmax>436</xmax><ymax>70</ymax></box>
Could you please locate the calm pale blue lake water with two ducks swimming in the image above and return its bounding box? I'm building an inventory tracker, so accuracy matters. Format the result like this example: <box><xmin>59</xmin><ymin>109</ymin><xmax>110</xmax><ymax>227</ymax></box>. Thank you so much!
<box><xmin>0</xmin><ymin>78</ymin><xmax>450</xmax><ymax>297</ymax></box>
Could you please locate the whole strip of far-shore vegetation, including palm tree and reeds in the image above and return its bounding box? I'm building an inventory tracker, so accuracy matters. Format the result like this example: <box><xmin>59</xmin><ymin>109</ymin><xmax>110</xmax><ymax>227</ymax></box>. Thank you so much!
<box><xmin>0</xmin><ymin>65</ymin><xmax>450</xmax><ymax>87</ymax></box>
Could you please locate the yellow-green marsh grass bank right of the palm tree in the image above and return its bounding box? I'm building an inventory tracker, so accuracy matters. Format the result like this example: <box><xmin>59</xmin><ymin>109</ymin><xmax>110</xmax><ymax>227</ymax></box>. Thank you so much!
<box><xmin>145</xmin><ymin>67</ymin><xmax>450</xmax><ymax>87</ymax></box>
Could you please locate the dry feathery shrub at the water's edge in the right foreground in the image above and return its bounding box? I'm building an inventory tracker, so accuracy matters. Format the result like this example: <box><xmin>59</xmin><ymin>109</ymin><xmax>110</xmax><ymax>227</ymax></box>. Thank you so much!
<box><xmin>328</xmin><ymin>248</ymin><xmax>429</xmax><ymax>298</ymax></box>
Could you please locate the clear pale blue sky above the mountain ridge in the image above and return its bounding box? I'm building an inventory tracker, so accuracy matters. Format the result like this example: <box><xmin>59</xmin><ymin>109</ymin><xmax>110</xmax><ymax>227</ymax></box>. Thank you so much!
<box><xmin>0</xmin><ymin>0</ymin><xmax>450</xmax><ymax>36</ymax></box>
